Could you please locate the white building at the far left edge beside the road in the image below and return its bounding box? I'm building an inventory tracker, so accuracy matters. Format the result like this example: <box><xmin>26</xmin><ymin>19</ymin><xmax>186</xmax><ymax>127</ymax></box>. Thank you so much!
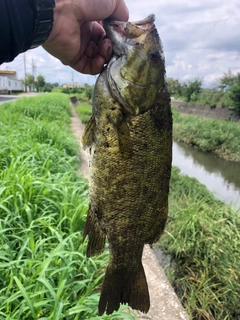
<box><xmin>0</xmin><ymin>70</ymin><xmax>24</xmax><ymax>94</ymax></box>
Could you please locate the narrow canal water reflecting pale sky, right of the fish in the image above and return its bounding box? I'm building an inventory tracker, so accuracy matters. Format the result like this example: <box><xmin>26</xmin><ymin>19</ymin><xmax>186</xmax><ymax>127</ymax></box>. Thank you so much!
<box><xmin>173</xmin><ymin>142</ymin><xmax>240</xmax><ymax>208</ymax></box>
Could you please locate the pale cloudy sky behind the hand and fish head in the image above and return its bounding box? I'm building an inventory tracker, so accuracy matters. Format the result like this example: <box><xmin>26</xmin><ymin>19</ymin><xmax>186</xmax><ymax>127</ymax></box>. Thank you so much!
<box><xmin>0</xmin><ymin>0</ymin><xmax>240</xmax><ymax>87</ymax></box>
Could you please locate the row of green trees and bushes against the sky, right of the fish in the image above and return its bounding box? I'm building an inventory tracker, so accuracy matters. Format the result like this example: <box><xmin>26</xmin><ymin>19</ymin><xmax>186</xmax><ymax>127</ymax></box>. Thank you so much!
<box><xmin>168</xmin><ymin>70</ymin><xmax>240</xmax><ymax>115</ymax></box>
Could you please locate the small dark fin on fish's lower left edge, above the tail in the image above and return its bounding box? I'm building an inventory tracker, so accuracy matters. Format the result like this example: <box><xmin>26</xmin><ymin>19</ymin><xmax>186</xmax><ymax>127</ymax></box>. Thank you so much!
<box><xmin>83</xmin><ymin>210</ymin><xmax>106</xmax><ymax>257</ymax></box>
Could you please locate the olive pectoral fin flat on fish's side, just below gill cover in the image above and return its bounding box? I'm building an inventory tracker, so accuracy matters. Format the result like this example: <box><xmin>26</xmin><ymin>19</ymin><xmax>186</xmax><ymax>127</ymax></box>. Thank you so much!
<box><xmin>109</xmin><ymin>109</ymin><xmax>133</xmax><ymax>158</ymax></box>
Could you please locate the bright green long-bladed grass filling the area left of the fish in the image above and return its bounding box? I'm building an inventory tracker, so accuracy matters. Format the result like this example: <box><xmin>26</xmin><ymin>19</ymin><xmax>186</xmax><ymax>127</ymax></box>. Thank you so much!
<box><xmin>0</xmin><ymin>94</ymin><xmax>133</xmax><ymax>320</ymax></box>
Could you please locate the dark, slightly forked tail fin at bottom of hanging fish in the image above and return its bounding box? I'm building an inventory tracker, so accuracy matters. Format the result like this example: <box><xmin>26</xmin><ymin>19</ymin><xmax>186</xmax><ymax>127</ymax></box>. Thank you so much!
<box><xmin>98</xmin><ymin>264</ymin><xmax>150</xmax><ymax>316</ymax></box>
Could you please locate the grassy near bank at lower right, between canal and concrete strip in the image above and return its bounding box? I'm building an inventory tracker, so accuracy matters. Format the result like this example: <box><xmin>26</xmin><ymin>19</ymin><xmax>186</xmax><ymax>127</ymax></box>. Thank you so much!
<box><xmin>159</xmin><ymin>167</ymin><xmax>240</xmax><ymax>320</ymax></box>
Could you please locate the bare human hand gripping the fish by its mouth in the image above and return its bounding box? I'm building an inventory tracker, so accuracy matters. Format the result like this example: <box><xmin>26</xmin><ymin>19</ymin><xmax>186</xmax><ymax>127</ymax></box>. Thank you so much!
<box><xmin>43</xmin><ymin>0</ymin><xmax>128</xmax><ymax>74</ymax></box>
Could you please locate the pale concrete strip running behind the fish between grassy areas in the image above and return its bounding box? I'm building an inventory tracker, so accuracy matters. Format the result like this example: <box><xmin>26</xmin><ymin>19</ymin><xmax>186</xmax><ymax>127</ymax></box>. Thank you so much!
<box><xmin>71</xmin><ymin>107</ymin><xmax>189</xmax><ymax>320</ymax></box>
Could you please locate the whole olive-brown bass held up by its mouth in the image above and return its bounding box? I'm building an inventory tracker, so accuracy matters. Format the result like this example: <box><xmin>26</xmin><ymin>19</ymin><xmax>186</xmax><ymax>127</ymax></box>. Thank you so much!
<box><xmin>82</xmin><ymin>14</ymin><xmax>172</xmax><ymax>315</ymax></box>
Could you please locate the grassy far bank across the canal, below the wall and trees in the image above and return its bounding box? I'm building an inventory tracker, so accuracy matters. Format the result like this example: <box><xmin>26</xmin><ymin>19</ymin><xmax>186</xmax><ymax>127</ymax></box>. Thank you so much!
<box><xmin>173</xmin><ymin>108</ymin><xmax>240</xmax><ymax>162</ymax></box>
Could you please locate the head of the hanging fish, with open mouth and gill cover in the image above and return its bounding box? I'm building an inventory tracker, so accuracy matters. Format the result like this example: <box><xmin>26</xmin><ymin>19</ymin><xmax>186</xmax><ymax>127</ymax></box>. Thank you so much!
<box><xmin>104</xmin><ymin>15</ymin><xmax>165</xmax><ymax>115</ymax></box>
